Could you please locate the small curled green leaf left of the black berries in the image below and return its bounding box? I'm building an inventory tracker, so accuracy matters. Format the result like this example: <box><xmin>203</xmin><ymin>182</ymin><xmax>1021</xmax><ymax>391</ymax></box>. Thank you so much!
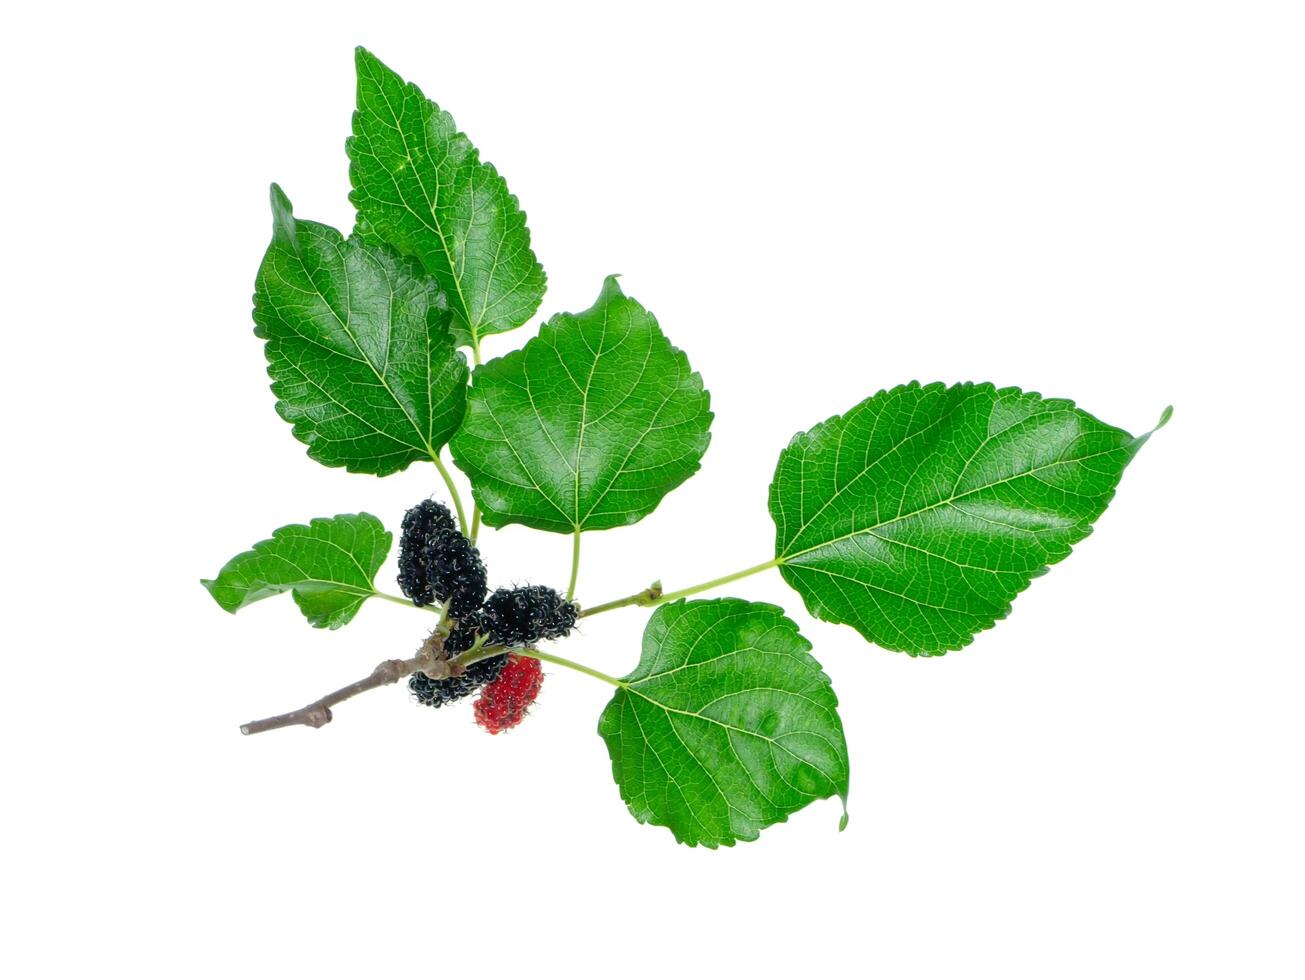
<box><xmin>202</xmin><ymin>514</ymin><xmax>392</xmax><ymax>629</ymax></box>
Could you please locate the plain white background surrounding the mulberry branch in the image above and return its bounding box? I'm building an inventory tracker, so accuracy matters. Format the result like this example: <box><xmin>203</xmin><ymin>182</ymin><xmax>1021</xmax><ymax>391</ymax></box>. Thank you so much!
<box><xmin>0</xmin><ymin>1</ymin><xmax>1305</xmax><ymax>977</ymax></box>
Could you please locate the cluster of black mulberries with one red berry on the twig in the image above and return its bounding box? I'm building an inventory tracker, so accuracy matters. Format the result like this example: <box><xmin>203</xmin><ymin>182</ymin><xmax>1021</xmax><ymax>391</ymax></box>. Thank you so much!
<box><xmin>399</xmin><ymin>500</ymin><xmax>578</xmax><ymax>735</ymax></box>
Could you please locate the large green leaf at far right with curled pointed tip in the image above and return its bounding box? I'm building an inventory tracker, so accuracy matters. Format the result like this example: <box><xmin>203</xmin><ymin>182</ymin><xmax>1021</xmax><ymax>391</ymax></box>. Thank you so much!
<box><xmin>770</xmin><ymin>382</ymin><xmax>1168</xmax><ymax>655</ymax></box>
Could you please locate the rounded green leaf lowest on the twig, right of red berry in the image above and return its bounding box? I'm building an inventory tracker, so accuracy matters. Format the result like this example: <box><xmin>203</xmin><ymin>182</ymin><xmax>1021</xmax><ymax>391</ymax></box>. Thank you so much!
<box><xmin>598</xmin><ymin>599</ymin><xmax>847</xmax><ymax>847</ymax></box>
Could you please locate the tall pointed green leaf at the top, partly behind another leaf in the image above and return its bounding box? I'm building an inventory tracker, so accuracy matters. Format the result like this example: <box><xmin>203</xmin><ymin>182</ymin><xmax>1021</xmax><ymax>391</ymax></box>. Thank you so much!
<box><xmin>347</xmin><ymin>48</ymin><xmax>544</xmax><ymax>347</ymax></box>
